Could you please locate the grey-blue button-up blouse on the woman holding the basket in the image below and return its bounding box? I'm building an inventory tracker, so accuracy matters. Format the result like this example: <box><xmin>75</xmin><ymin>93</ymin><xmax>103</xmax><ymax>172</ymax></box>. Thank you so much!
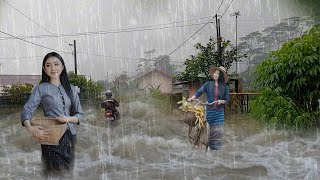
<box><xmin>21</xmin><ymin>82</ymin><xmax>83</xmax><ymax>135</ymax></box>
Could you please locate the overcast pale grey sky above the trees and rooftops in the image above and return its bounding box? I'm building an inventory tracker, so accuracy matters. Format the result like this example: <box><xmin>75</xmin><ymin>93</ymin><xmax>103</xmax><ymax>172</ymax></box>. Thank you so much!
<box><xmin>0</xmin><ymin>0</ymin><xmax>316</xmax><ymax>80</ymax></box>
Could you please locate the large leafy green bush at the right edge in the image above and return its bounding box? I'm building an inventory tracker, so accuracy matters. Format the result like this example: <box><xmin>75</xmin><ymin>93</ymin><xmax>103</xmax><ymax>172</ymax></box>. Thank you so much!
<box><xmin>255</xmin><ymin>25</ymin><xmax>320</xmax><ymax>130</ymax></box>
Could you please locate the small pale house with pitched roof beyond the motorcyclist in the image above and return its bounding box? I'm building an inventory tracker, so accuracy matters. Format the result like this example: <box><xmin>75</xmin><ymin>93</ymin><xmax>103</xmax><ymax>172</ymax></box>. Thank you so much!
<box><xmin>135</xmin><ymin>69</ymin><xmax>172</xmax><ymax>94</ymax></box>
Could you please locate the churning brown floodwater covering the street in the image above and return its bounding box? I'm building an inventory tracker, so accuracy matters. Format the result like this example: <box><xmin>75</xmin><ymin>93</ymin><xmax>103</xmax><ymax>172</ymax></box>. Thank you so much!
<box><xmin>0</xmin><ymin>102</ymin><xmax>320</xmax><ymax>180</ymax></box>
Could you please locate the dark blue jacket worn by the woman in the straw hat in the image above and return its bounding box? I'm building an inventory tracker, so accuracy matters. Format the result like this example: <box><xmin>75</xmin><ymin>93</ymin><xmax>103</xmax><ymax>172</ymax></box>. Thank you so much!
<box><xmin>195</xmin><ymin>81</ymin><xmax>230</xmax><ymax>110</ymax></box>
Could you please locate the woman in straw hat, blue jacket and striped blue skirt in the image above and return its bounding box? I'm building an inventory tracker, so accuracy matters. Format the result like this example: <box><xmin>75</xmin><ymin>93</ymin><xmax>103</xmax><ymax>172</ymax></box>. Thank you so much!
<box><xmin>188</xmin><ymin>66</ymin><xmax>230</xmax><ymax>150</ymax></box>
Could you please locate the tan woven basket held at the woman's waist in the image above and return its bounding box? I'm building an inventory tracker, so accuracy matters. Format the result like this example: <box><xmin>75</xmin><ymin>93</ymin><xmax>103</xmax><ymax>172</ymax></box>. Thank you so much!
<box><xmin>30</xmin><ymin>117</ymin><xmax>68</xmax><ymax>145</ymax></box>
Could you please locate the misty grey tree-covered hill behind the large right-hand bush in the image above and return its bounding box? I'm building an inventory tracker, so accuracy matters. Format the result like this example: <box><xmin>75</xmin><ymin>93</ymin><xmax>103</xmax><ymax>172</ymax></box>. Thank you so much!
<box><xmin>238</xmin><ymin>17</ymin><xmax>320</xmax><ymax>88</ymax></box>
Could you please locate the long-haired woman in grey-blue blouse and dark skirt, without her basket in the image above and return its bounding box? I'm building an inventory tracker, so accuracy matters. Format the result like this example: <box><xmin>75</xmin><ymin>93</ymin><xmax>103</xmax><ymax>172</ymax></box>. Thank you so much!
<box><xmin>21</xmin><ymin>52</ymin><xmax>83</xmax><ymax>175</ymax></box>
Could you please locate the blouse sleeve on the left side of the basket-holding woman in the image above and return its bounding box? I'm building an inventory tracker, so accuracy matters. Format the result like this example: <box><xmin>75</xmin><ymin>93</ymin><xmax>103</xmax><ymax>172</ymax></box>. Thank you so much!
<box><xmin>21</xmin><ymin>86</ymin><xmax>41</xmax><ymax>126</ymax></box>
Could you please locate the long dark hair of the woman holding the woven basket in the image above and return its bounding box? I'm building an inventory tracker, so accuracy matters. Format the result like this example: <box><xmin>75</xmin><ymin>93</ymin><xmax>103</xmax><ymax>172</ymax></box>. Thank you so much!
<box><xmin>41</xmin><ymin>52</ymin><xmax>75</xmax><ymax>115</ymax></box>
